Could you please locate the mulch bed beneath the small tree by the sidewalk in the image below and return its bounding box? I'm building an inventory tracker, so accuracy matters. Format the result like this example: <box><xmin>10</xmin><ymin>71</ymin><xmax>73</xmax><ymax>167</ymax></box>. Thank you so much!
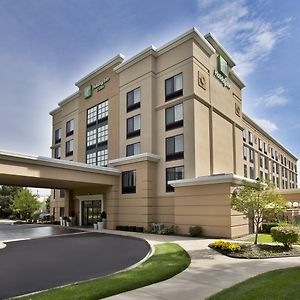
<box><xmin>208</xmin><ymin>243</ymin><xmax>300</xmax><ymax>259</ymax></box>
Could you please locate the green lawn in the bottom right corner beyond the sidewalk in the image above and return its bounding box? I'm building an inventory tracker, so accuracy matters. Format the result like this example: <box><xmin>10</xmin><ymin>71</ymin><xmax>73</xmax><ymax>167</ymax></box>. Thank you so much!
<box><xmin>208</xmin><ymin>267</ymin><xmax>300</xmax><ymax>300</ymax></box>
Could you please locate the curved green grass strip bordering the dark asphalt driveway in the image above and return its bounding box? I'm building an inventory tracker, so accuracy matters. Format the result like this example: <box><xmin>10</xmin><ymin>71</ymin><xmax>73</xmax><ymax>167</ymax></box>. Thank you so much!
<box><xmin>18</xmin><ymin>243</ymin><xmax>191</xmax><ymax>300</ymax></box>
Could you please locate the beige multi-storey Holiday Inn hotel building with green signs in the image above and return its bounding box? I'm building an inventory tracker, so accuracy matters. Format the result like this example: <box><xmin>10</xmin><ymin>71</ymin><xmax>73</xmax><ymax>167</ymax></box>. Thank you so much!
<box><xmin>50</xmin><ymin>28</ymin><xmax>297</xmax><ymax>237</ymax></box>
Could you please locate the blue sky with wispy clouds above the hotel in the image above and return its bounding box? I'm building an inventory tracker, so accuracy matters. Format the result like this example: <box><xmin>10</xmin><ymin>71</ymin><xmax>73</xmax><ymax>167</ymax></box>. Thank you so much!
<box><xmin>0</xmin><ymin>0</ymin><xmax>300</xmax><ymax>195</ymax></box>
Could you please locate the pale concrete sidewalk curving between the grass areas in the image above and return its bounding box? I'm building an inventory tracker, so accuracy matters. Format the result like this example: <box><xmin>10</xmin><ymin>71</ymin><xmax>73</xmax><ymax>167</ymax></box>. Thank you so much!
<box><xmin>101</xmin><ymin>230</ymin><xmax>300</xmax><ymax>300</ymax></box>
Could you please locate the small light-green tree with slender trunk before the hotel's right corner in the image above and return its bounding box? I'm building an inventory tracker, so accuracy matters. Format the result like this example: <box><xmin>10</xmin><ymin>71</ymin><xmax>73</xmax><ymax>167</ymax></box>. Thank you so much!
<box><xmin>230</xmin><ymin>179</ymin><xmax>287</xmax><ymax>244</ymax></box>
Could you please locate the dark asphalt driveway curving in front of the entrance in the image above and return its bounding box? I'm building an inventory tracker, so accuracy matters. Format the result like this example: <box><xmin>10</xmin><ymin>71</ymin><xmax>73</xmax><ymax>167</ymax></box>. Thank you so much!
<box><xmin>0</xmin><ymin>233</ymin><xmax>150</xmax><ymax>299</ymax></box>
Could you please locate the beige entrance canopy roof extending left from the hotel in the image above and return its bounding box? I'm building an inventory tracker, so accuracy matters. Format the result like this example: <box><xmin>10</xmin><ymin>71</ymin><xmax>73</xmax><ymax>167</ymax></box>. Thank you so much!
<box><xmin>0</xmin><ymin>150</ymin><xmax>121</xmax><ymax>189</ymax></box>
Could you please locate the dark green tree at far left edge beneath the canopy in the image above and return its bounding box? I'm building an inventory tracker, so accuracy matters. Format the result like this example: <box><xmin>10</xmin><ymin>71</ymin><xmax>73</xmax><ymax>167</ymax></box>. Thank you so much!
<box><xmin>0</xmin><ymin>185</ymin><xmax>23</xmax><ymax>218</ymax></box>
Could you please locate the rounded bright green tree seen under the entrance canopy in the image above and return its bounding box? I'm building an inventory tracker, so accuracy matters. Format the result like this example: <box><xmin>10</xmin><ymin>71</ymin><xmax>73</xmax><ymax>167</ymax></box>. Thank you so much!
<box><xmin>13</xmin><ymin>188</ymin><xmax>41</xmax><ymax>219</ymax></box>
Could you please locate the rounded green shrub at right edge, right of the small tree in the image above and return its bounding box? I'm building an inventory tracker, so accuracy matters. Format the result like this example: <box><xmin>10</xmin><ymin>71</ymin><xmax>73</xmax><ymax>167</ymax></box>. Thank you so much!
<box><xmin>271</xmin><ymin>226</ymin><xmax>300</xmax><ymax>247</ymax></box>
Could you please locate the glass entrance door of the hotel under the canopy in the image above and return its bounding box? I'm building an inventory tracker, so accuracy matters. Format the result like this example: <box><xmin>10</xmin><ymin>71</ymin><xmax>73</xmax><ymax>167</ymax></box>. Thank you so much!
<box><xmin>81</xmin><ymin>200</ymin><xmax>101</xmax><ymax>226</ymax></box>
